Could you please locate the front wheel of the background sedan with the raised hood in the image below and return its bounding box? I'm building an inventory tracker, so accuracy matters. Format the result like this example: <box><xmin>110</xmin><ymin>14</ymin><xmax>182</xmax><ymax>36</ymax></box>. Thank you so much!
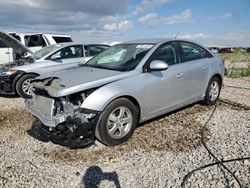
<box><xmin>16</xmin><ymin>74</ymin><xmax>37</xmax><ymax>99</ymax></box>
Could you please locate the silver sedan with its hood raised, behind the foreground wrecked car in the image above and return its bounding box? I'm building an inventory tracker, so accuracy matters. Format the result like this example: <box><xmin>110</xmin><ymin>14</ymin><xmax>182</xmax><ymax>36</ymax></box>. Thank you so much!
<box><xmin>0</xmin><ymin>30</ymin><xmax>109</xmax><ymax>98</ymax></box>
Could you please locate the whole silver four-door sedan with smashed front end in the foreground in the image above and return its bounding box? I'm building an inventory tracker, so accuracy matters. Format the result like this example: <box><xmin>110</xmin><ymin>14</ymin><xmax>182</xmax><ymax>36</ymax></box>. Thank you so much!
<box><xmin>26</xmin><ymin>39</ymin><xmax>224</xmax><ymax>147</ymax></box>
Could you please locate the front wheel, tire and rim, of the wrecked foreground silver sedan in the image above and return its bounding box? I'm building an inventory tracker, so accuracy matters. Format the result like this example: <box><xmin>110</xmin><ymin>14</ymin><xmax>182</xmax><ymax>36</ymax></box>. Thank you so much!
<box><xmin>96</xmin><ymin>98</ymin><xmax>138</xmax><ymax>146</ymax></box>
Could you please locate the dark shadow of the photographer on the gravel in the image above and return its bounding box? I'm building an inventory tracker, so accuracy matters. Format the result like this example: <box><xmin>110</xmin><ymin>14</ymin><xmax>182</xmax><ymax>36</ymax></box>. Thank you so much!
<box><xmin>82</xmin><ymin>165</ymin><xmax>121</xmax><ymax>188</ymax></box>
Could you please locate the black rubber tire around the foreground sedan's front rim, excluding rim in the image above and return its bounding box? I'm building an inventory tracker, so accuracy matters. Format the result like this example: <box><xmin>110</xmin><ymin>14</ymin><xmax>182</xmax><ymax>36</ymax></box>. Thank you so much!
<box><xmin>96</xmin><ymin>98</ymin><xmax>138</xmax><ymax>146</ymax></box>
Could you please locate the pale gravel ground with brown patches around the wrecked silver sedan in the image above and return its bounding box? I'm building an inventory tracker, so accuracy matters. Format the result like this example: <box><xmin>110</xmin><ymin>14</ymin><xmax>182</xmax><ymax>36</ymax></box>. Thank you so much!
<box><xmin>0</xmin><ymin>78</ymin><xmax>250</xmax><ymax>187</ymax></box>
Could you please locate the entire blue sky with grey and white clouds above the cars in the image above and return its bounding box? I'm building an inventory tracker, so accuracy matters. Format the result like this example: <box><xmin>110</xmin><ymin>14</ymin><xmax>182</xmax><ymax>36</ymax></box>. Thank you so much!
<box><xmin>0</xmin><ymin>0</ymin><xmax>250</xmax><ymax>46</ymax></box>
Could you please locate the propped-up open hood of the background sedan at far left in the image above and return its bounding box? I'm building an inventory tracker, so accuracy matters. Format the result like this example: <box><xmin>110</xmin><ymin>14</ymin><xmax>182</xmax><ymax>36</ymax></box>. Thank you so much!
<box><xmin>0</xmin><ymin>31</ymin><xmax>34</xmax><ymax>56</ymax></box>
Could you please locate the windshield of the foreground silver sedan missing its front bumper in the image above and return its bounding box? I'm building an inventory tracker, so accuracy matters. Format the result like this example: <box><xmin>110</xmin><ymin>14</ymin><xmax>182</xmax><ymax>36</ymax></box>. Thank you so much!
<box><xmin>84</xmin><ymin>44</ymin><xmax>153</xmax><ymax>71</ymax></box>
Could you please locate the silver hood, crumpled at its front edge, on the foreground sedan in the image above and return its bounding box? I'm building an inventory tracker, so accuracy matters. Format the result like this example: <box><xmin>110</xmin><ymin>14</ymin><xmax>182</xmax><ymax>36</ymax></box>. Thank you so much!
<box><xmin>32</xmin><ymin>67</ymin><xmax>138</xmax><ymax>97</ymax></box>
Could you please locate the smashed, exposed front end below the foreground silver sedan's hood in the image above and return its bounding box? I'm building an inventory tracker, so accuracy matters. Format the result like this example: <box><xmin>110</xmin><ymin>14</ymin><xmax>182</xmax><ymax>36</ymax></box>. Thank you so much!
<box><xmin>25</xmin><ymin>83</ymin><xmax>100</xmax><ymax>148</ymax></box>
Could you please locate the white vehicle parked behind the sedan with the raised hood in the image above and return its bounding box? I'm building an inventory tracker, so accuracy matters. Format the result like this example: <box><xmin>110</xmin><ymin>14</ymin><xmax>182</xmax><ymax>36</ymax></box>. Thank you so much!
<box><xmin>0</xmin><ymin>32</ymin><xmax>72</xmax><ymax>64</ymax></box>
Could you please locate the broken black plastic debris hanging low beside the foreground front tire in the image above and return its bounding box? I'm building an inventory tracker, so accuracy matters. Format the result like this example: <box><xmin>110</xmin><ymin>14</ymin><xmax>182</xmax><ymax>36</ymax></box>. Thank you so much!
<box><xmin>28</xmin><ymin>109</ymin><xmax>100</xmax><ymax>149</ymax></box>
